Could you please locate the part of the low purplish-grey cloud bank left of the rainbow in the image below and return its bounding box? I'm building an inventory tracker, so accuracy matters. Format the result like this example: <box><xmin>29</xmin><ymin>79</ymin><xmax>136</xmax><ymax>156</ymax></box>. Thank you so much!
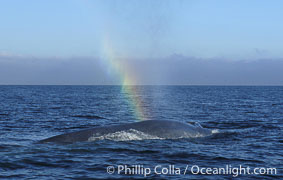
<box><xmin>0</xmin><ymin>57</ymin><xmax>111</xmax><ymax>85</ymax></box>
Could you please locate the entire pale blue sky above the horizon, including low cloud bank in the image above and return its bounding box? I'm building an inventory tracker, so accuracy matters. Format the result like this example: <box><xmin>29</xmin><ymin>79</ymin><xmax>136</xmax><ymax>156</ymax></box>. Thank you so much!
<box><xmin>0</xmin><ymin>0</ymin><xmax>283</xmax><ymax>85</ymax></box>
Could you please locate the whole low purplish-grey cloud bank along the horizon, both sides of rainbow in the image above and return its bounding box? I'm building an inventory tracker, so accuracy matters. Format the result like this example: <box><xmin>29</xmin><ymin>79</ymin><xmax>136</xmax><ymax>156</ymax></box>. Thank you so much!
<box><xmin>0</xmin><ymin>54</ymin><xmax>283</xmax><ymax>85</ymax></box>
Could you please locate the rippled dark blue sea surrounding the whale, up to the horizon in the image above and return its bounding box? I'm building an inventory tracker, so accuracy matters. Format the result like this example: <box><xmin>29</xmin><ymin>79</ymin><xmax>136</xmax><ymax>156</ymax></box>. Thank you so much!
<box><xmin>0</xmin><ymin>86</ymin><xmax>283</xmax><ymax>179</ymax></box>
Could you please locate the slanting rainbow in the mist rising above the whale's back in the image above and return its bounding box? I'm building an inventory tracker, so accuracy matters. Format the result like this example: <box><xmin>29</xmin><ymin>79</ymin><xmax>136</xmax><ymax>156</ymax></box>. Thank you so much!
<box><xmin>102</xmin><ymin>38</ymin><xmax>148</xmax><ymax>121</ymax></box>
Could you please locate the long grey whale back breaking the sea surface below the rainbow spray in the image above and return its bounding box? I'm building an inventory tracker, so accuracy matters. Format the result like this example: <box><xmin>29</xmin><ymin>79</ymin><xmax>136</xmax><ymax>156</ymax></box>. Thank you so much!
<box><xmin>39</xmin><ymin>120</ymin><xmax>212</xmax><ymax>143</ymax></box>
